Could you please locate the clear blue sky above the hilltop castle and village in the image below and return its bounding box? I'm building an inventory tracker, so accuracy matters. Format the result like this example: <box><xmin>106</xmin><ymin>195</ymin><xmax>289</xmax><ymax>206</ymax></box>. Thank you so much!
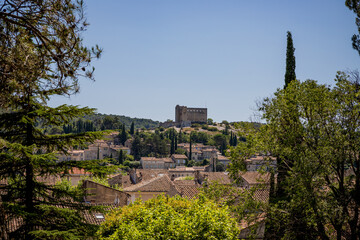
<box><xmin>51</xmin><ymin>0</ymin><xmax>360</xmax><ymax>122</ymax></box>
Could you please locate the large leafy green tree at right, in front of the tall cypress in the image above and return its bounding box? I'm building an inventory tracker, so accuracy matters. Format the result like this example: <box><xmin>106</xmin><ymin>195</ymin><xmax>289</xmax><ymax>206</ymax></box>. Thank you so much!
<box><xmin>262</xmin><ymin>73</ymin><xmax>360</xmax><ymax>239</ymax></box>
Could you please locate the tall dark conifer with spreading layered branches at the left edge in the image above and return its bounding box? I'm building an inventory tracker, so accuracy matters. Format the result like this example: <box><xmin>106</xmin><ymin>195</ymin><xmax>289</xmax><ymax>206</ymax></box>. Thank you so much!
<box><xmin>0</xmin><ymin>0</ymin><xmax>102</xmax><ymax>239</ymax></box>
